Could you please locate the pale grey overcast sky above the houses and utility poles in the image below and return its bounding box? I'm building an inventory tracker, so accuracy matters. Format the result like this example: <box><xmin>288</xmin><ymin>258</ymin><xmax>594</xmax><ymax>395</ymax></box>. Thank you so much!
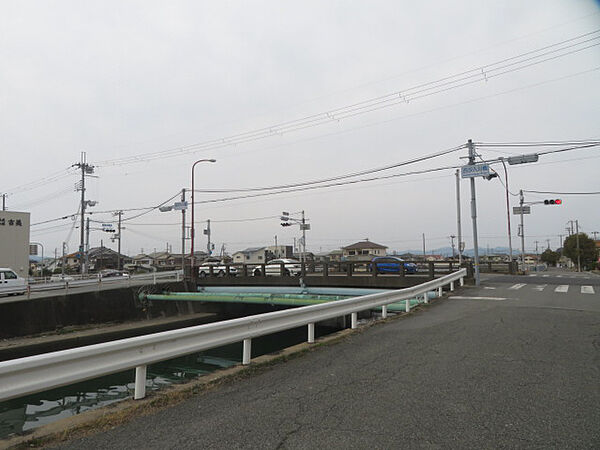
<box><xmin>0</xmin><ymin>0</ymin><xmax>600</xmax><ymax>255</ymax></box>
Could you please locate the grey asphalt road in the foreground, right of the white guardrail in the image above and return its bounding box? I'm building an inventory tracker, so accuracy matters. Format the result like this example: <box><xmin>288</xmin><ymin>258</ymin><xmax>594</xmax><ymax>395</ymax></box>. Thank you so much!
<box><xmin>56</xmin><ymin>273</ymin><xmax>600</xmax><ymax>450</ymax></box>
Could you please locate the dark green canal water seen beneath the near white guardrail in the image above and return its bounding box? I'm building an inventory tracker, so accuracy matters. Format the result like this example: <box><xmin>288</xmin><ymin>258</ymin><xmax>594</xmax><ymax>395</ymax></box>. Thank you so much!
<box><xmin>0</xmin><ymin>326</ymin><xmax>334</xmax><ymax>439</ymax></box>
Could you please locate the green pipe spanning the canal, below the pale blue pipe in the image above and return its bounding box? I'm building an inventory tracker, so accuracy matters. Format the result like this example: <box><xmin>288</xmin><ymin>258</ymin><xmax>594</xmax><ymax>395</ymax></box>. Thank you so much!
<box><xmin>140</xmin><ymin>292</ymin><xmax>419</xmax><ymax>312</ymax></box>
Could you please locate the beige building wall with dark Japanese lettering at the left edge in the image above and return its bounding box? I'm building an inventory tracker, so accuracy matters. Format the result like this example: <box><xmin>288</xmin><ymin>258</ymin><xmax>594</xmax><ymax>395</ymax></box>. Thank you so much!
<box><xmin>0</xmin><ymin>211</ymin><xmax>30</xmax><ymax>278</ymax></box>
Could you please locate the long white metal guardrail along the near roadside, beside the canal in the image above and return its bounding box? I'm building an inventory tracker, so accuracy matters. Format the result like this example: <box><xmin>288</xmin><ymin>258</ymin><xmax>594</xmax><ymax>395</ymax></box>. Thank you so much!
<box><xmin>0</xmin><ymin>269</ymin><xmax>467</xmax><ymax>401</ymax></box>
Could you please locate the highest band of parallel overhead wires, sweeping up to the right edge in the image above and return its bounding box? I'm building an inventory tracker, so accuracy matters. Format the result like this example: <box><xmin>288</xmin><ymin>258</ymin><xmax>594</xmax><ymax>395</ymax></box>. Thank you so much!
<box><xmin>97</xmin><ymin>29</ymin><xmax>600</xmax><ymax>166</ymax></box>
